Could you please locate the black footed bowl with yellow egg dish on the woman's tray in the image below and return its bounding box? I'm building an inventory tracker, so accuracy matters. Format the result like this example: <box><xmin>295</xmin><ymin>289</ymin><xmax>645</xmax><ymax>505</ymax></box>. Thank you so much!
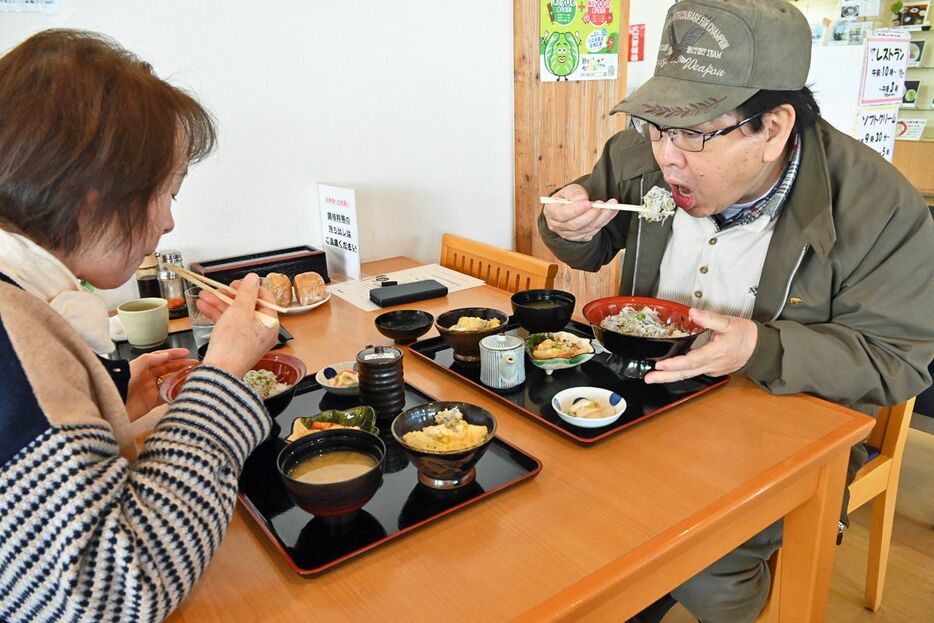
<box><xmin>390</xmin><ymin>402</ymin><xmax>496</xmax><ymax>489</ymax></box>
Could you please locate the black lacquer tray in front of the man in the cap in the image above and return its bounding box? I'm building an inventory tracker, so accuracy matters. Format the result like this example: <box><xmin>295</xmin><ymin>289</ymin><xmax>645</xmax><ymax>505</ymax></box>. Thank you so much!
<box><xmin>409</xmin><ymin>319</ymin><xmax>730</xmax><ymax>444</ymax></box>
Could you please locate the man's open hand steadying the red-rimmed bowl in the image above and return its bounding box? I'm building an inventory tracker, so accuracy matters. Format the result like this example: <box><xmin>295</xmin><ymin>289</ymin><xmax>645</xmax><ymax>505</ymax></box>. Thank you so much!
<box><xmin>645</xmin><ymin>308</ymin><xmax>759</xmax><ymax>383</ymax></box>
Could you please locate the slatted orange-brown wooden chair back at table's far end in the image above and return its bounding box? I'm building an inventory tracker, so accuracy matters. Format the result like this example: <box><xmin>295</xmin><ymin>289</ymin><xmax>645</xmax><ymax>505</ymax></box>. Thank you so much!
<box><xmin>441</xmin><ymin>234</ymin><xmax>558</xmax><ymax>292</ymax></box>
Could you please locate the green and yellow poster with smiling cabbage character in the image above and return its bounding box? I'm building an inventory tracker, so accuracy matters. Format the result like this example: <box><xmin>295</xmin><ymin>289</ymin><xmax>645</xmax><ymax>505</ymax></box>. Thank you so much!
<box><xmin>539</xmin><ymin>0</ymin><xmax>626</xmax><ymax>82</ymax></box>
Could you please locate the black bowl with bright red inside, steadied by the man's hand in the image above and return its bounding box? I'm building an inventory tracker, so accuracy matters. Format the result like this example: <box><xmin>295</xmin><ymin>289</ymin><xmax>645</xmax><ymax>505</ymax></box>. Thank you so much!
<box><xmin>583</xmin><ymin>296</ymin><xmax>704</xmax><ymax>378</ymax></box>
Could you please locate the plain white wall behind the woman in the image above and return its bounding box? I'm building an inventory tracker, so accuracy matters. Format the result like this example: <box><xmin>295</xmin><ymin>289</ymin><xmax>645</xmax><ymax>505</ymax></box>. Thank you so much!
<box><xmin>0</xmin><ymin>0</ymin><xmax>514</xmax><ymax>308</ymax></box>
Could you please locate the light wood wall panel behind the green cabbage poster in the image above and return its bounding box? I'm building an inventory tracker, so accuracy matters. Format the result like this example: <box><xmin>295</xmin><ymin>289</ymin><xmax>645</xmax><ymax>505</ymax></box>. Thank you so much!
<box><xmin>513</xmin><ymin>0</ymin><xmax>629</xmax><ymax>312</ymax></box>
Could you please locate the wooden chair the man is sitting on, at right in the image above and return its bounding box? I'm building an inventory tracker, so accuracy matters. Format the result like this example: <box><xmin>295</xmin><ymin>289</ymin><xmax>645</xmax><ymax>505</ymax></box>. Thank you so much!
<box><xmin>756</xmin><ymin>398</ymin><xmax>915</xmax><ymax>623</ymax></box>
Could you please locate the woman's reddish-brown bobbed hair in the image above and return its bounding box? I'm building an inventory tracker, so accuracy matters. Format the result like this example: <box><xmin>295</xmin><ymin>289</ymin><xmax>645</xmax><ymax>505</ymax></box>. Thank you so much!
<box><xmin>0</xmin><ymin>30</ymin><xmax>216</xmax><ymax>253</ymax></box>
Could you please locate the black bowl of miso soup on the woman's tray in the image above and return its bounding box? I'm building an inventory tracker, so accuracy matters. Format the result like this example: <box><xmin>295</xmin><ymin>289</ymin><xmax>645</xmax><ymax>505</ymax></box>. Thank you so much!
<box><xmin>276</xmin><ymin>428</ymin><xmax>386</xmax><ymax>520</ymax></box>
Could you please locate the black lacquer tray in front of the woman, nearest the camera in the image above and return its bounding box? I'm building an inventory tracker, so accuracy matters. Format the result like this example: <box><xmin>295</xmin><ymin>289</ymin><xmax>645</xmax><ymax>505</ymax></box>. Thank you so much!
<box><xmin>239</xmin><ymin>375</ymin><xmax>542</xmax><ymax>576</ymax></box>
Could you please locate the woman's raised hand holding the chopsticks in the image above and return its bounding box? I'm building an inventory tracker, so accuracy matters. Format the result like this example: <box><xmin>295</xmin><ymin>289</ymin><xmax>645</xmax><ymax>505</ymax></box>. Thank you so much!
<box><xmin>198</xmin><ymin>273</ymin><xmax>279</xmax><ymax>378</ymax></box>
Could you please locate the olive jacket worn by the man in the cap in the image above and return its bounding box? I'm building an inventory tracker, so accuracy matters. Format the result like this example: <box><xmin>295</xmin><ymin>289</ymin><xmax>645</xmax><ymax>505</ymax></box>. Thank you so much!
<box><xmin>538</xmin><ymin>120</ymin><xmax>934</xmax><ymax>413</ymax></box>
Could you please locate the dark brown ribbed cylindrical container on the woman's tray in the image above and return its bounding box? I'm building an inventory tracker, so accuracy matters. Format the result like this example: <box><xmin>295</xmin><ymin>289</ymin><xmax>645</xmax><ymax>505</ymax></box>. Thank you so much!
<box><xmin>357</xmin><ymin>346</ymin><xmax>405</xmax><ymax>420</ymax></box>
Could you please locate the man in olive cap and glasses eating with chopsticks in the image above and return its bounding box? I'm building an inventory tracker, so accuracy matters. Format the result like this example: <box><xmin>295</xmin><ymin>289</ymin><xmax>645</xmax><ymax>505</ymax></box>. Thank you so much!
<box><xmin>538</xmin><ymin>0</ymin><xmax>934</xmax><ymax>623</ymax></box>
